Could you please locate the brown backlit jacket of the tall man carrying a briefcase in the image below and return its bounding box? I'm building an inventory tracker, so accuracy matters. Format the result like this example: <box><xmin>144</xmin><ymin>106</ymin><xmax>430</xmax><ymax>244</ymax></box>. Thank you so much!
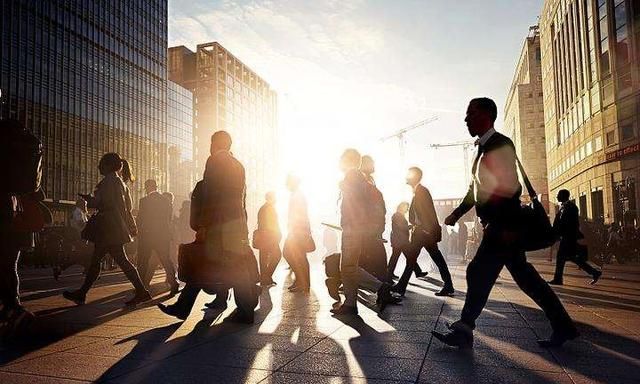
<box><xmin>201</xmin><ymin>151</ymin><xmax>249</xmax><ymax>255</ymax></box>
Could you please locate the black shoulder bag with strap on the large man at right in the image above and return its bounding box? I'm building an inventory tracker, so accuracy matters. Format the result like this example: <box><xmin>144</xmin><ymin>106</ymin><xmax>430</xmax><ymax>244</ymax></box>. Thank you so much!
<box><xmin>516</xmin><ymin>155</ymin><xmax>556</xmax><ymax>251</ymax></box>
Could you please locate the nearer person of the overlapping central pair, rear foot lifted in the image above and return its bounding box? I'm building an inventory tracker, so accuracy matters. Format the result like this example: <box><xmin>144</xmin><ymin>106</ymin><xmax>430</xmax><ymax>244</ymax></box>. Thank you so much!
<box><xmin>331</xmin><ymin>149</ymin><xmax>399</xmax><ymax>316</ymax></box>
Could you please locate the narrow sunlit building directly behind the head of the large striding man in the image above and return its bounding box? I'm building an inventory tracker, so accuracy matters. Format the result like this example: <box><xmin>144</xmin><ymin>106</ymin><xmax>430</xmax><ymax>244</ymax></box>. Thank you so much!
<box><xmin>503</xmin><ymin>26</ymin><xmax>549</xmax><ymax>210</ymax></box>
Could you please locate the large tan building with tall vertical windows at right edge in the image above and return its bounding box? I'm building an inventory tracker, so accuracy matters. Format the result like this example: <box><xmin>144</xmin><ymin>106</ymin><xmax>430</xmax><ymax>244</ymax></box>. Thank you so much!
<box><xmin>540</xmin><ymin>0</ymin><xmax>640</xmax><ymax>223</ymax></box>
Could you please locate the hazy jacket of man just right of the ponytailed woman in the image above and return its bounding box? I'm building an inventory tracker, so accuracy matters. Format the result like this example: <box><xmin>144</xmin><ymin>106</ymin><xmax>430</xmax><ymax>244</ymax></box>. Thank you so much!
<box><xmin>138</xmin><ymin>191</ymin><xmax>173</xmax><ymax>240</ymax></box>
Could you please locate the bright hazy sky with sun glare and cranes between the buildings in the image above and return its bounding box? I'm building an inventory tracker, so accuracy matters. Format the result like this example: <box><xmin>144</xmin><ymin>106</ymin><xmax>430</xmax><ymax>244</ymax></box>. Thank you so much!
<box><xmin>169</xmin><ymin>0</ymin><xmax>543</xmax><ymax>224</ymax></box>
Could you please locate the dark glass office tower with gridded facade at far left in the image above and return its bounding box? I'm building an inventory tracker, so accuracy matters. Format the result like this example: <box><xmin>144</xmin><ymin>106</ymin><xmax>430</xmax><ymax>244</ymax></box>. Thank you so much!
<box><xmin>0</xmin><ymin>0</ymin><xmax>167</xmax><ymax>207</ymax></box>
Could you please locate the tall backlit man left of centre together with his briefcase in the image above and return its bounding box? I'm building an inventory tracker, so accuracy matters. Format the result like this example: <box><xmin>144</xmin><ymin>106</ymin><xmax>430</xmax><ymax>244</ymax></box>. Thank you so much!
<box><xmin>158</xmin><ymin>131</ymin><xmax>259</xmax><ymax>324</ymax></box>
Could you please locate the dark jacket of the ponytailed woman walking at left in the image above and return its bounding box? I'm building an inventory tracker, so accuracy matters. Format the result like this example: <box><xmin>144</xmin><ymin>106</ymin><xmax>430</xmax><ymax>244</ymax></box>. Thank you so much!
<box><xmin>87</xmin><ymin>172</ymin><xmax>135</xmax><ymax>246</ymax></box>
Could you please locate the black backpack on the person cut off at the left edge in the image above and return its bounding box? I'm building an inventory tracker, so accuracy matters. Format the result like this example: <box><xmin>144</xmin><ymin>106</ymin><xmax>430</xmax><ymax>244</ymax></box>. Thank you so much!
<box><xmin>2</xmin><ymin>124</ymin><xmax>42</xmax><ymax>195</ymax></box>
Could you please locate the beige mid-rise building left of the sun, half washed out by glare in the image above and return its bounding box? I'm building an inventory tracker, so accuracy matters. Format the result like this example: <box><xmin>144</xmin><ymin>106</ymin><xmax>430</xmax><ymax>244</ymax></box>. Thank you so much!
<box><xmin>168</xmin><ymin>42</ymin><xmax>284</xmax><ymax>223</ymax></box>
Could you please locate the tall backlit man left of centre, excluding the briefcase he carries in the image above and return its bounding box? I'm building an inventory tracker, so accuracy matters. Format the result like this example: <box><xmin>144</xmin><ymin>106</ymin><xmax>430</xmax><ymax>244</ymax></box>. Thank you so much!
<box><xmin>158</xmin><ymin>131</ymin><xmax>258</xmax><ymax>324</ymax></box>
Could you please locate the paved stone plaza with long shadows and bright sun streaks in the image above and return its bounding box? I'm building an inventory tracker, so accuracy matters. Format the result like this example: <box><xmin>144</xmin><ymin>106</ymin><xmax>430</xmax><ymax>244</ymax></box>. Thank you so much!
<box><xmin>0</xmin><ymin>257</ymin><xmax>640</xmax><ymax>384</ymax></box>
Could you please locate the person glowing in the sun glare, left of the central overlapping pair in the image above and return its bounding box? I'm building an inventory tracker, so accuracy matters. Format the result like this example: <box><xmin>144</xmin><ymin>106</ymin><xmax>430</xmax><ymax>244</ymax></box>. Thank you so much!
<box><xmin>282</xmin><ymin>175</ymin><xmax>315</xmax><ymax>292</ymax></box>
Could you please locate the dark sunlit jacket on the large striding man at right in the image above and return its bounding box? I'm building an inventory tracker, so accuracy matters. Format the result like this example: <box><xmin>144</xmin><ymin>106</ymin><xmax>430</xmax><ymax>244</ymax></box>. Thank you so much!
<box><xmin>453</xmin><ymin>132</ymin><xmax>522</xmax><ymax>225</ymax></box>
